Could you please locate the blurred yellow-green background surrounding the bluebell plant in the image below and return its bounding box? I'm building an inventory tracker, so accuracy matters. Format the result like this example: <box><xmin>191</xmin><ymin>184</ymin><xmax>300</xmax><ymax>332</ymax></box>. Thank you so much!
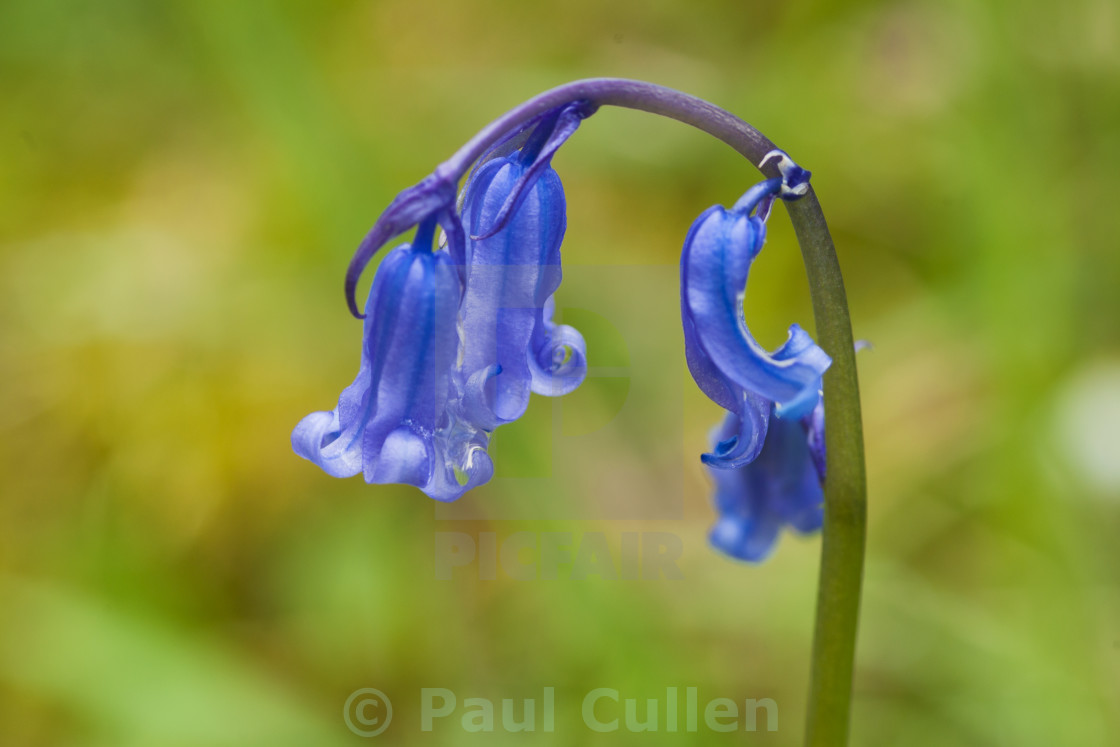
<box><xmin>0</xmin><ymin>0</ymin><xmax>1120</xmax><ymax>747</ymax></box>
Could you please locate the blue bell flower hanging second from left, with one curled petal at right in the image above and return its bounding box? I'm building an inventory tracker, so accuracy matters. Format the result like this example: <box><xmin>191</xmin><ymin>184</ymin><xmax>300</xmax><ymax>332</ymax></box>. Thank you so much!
<box><xmin>458</xmin><ymin>109</ymin><xmax>587</xmax><ymax>428</ymax></box>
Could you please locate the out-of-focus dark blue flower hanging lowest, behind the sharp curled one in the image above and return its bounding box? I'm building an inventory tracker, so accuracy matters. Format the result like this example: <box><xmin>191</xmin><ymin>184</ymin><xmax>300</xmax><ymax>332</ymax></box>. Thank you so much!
<box><xmin>708</xmin><ymin>403</ymin><xmax>824</xmax><ymax>562</ymax></box>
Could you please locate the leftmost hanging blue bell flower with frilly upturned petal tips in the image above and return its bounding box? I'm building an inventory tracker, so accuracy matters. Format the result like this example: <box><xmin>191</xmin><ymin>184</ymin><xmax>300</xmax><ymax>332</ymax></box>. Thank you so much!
<box><xmin>291</xmin><ymin>218</ymin><xmax>493</xmax><ymax>499</ymax></box>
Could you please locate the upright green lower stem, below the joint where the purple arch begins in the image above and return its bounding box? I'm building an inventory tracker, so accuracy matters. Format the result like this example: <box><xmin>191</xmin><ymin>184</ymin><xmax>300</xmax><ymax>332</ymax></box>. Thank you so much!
<box><xmin>786</xmin><ymin>189</ymin><xmax>867</xmax><ymax>747</ymax></box>
